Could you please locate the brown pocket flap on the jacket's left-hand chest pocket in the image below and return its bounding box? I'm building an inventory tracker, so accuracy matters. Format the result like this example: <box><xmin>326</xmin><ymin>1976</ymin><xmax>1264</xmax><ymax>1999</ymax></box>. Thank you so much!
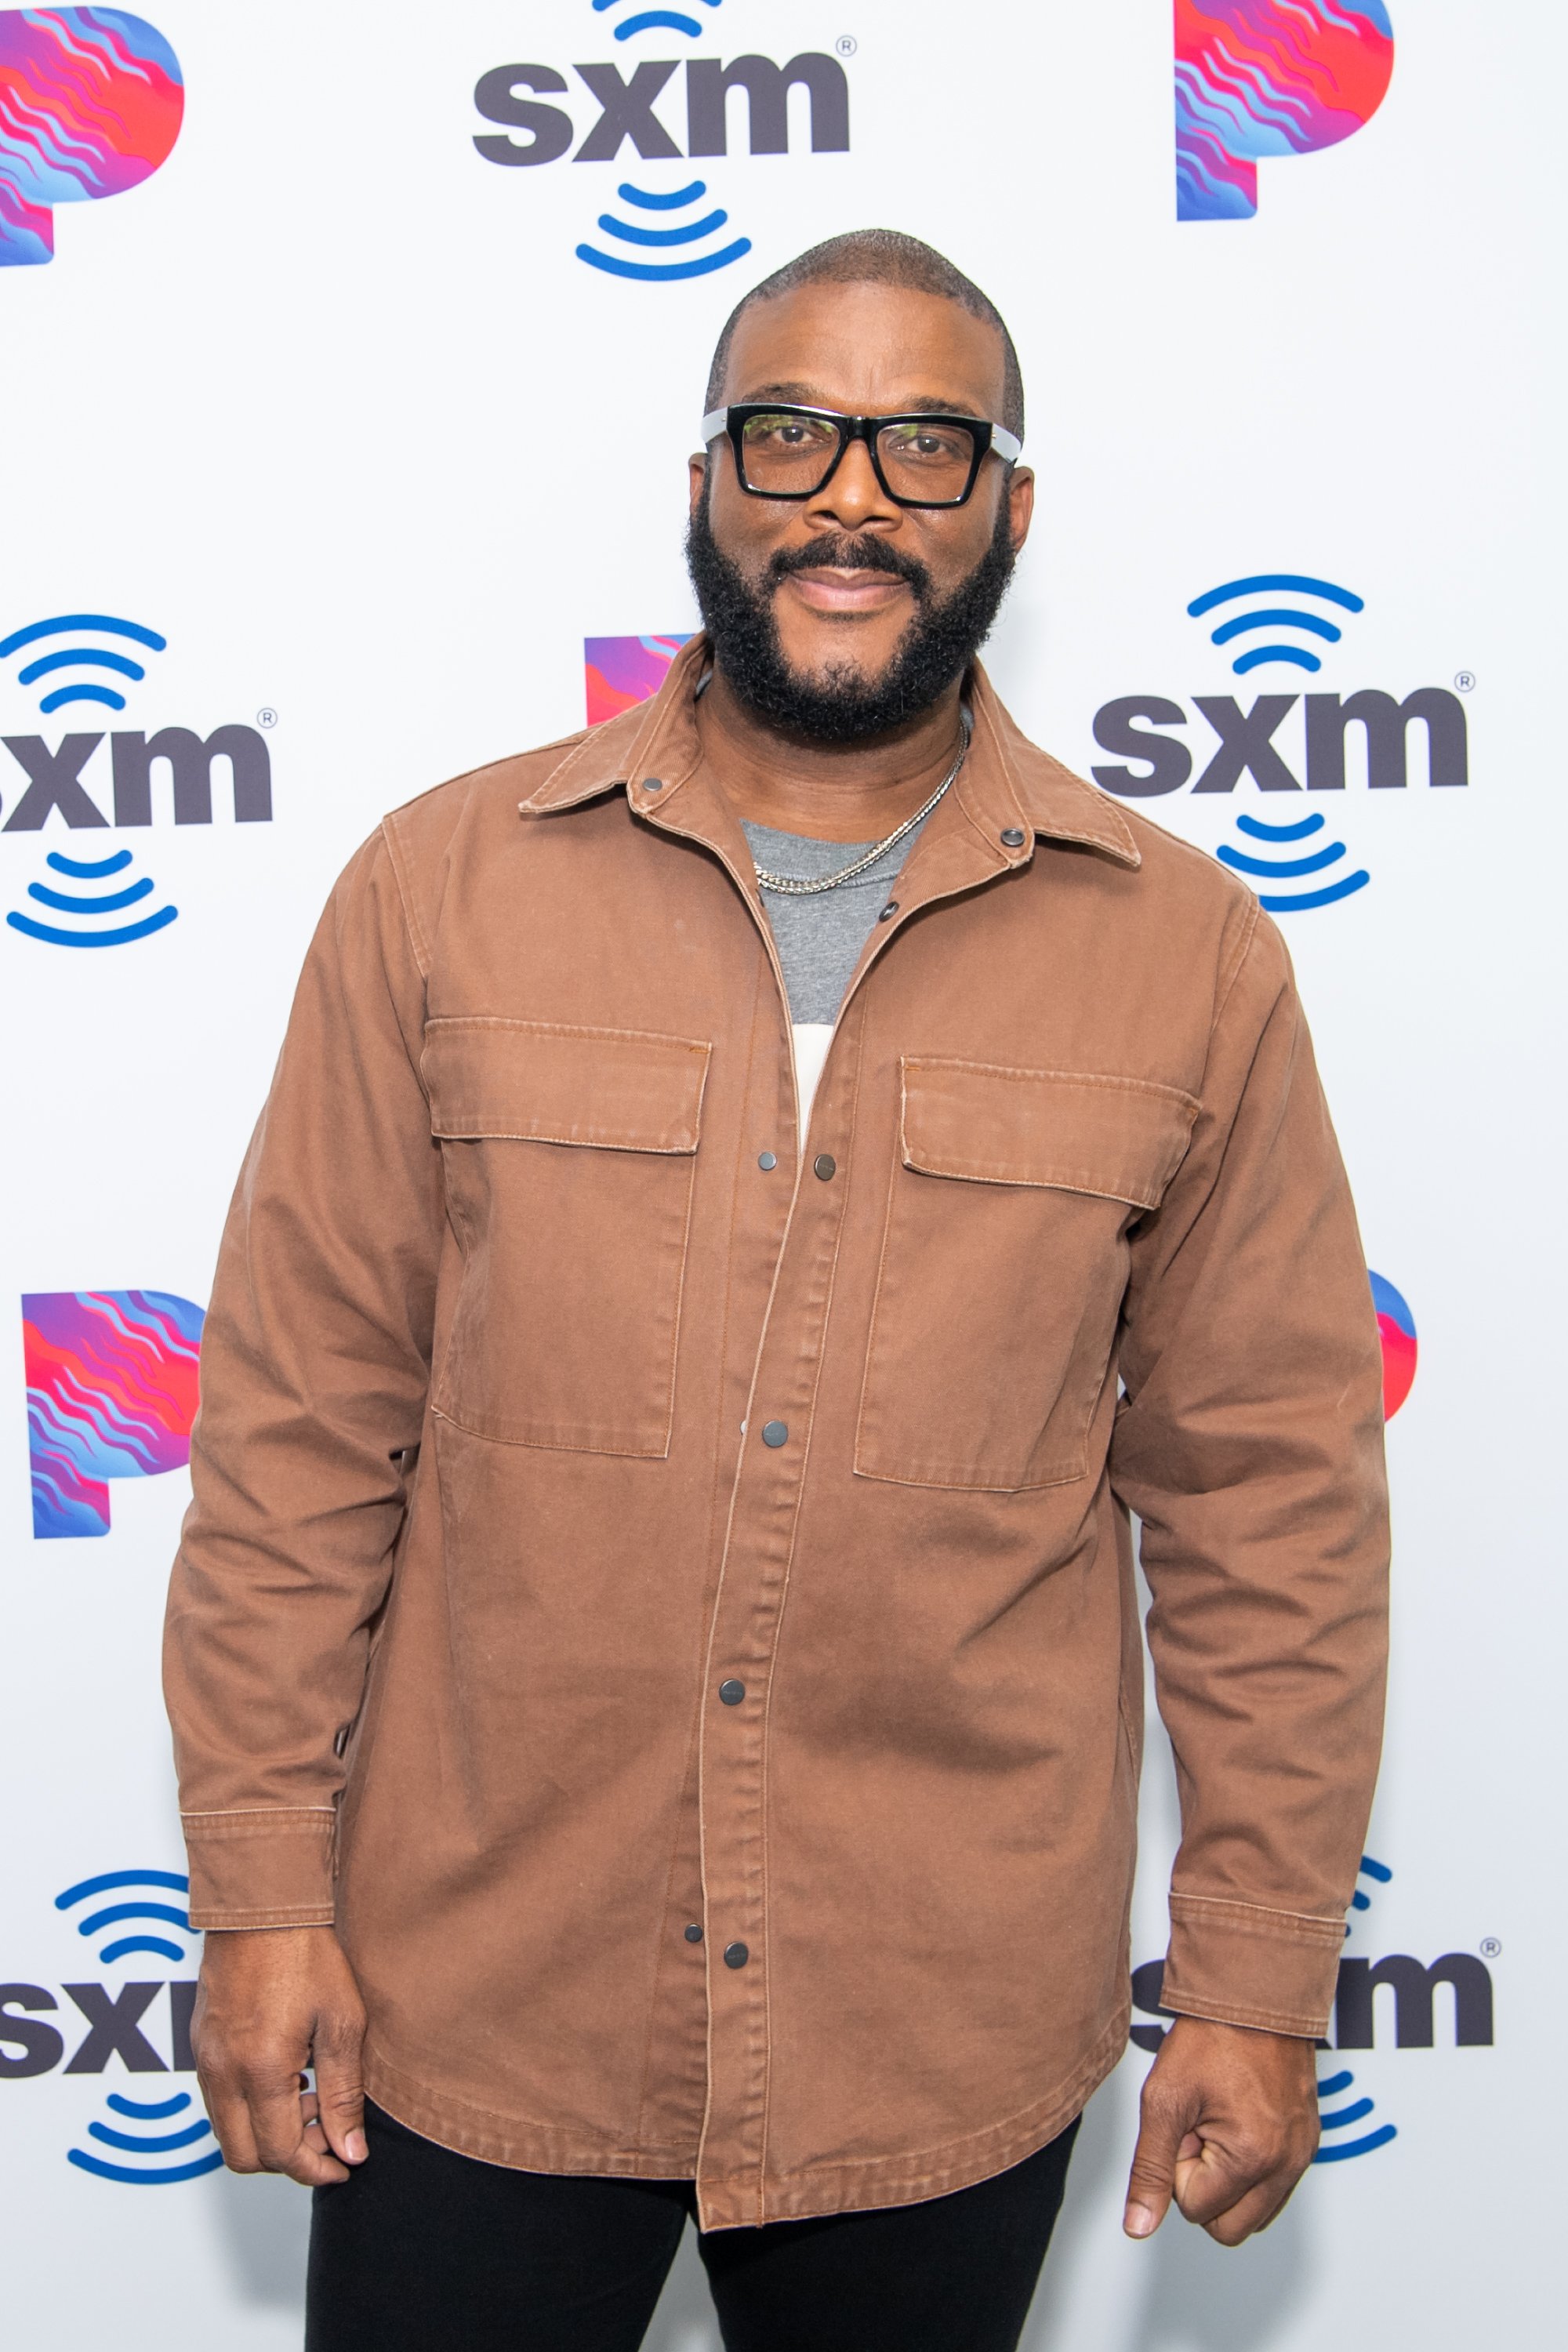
<box><xmin>421</xmin><ymin>1016</ymin><xmax>713</xmax><ymax>1152</ymax></box>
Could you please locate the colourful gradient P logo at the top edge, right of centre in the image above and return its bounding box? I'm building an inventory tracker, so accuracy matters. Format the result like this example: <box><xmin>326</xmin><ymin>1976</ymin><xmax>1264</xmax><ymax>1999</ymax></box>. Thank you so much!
<box><xmin>1175</xmin><ymin>0</ymin><xmax>1394</xmax><ymax>221</ymax></box>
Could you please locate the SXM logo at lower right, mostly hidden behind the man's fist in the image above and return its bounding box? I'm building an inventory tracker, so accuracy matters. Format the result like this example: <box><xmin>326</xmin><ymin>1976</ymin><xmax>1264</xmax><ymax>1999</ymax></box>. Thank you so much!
<box><xmin>1131</xmin><ymin>1853</ymin><xmax>1495</xmax><ymax>2164</ymax></box>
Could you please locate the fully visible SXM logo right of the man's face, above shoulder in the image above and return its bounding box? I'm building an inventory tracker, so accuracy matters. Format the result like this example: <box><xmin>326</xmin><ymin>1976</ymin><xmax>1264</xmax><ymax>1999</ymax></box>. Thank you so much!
<box><xmin>1091</xmin><ymin>572</ymin><xmax>1469</xmax><ymax>915</ymax></box>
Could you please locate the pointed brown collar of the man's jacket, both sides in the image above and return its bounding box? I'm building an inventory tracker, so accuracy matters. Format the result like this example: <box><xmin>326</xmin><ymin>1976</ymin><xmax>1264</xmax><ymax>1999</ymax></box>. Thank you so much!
<box><xmin>517</xmin><ymin>635</ymin><xmax>1142</xmax><ymax>868</ymax></box>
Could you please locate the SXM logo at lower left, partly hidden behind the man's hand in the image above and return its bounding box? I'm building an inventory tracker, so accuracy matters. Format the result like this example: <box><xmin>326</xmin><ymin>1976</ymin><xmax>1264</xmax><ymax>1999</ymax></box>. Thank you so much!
<box><xmin>0</xmin><ymin>1870</ymin><xmax>223</xmax><ymax>2187</ymax></box>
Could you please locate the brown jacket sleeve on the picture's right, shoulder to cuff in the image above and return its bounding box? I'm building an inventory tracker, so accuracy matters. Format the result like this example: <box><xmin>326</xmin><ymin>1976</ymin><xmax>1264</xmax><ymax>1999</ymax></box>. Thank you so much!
<box><xmin>1112</xmin><ymin>910</ymin><xmax>1387</xmax><ymax>2034</ymax></box>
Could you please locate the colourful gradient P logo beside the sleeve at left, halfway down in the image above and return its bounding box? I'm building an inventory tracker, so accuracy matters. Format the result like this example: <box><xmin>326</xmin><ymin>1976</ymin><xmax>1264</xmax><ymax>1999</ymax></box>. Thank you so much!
<box><xmin>21</xmin><ymin>1291</ymin><xmax>205</xmax><ymax>1538</ymax></box>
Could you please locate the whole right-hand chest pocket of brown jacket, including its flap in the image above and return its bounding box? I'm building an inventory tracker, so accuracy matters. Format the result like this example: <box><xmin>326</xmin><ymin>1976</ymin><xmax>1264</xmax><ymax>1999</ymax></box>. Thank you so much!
<box><xmin>855</xmin><ymin>1058</ymin><xmax>1199</xmax><ymax>1491</ymax></box>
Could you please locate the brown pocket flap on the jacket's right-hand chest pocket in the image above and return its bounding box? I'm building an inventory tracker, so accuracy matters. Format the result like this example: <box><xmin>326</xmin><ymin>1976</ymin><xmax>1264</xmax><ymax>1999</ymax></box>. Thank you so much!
<box><xmin>902</xmin><ymin>1056</ymin><xmax>1199</xmax><ymax>1209</ymax></box>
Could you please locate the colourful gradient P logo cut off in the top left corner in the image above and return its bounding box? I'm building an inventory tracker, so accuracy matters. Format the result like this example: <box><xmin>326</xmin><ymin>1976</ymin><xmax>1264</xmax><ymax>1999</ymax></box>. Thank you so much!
<box><xmin>0</xmin><ymin>7</ymin><xmax>186</xmax><ymax>268</ymax></box>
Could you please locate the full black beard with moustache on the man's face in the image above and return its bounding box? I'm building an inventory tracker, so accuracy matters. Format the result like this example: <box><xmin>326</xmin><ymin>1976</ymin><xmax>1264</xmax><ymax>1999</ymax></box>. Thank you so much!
<box><xmin>687</xmin><ymin>496</ymin><xmax>1013</xmax><ymax>743</ymax></box>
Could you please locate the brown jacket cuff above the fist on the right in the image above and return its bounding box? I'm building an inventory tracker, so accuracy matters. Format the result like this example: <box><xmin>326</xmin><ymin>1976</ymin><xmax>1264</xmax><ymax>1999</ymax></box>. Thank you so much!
<box><xmin>1159</xmin><ymin>1893</ymin><xmax>1345</xmax><ymax>2042</ymax></box>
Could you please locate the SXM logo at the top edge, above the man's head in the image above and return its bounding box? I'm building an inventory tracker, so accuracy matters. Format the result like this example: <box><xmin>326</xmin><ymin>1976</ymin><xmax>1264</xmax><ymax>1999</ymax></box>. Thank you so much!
<box><xmin>475</xmin><ymin>0</ymin><xmax>853</xmax><ymax>285</ymax></box>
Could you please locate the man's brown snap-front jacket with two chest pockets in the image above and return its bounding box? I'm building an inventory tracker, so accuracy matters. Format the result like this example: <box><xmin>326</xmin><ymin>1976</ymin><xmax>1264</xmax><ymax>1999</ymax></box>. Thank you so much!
<box><xmin>167</xmin><ymin>640</ymin><xmax>1387</xmax><ymax>2227</ymax></box>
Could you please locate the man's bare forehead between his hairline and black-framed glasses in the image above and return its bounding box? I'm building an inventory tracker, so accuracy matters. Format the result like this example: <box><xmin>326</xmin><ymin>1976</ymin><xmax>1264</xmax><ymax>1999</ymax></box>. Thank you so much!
<box><xmin>727</xmin><ymin>282</ymin><xmax>1004</xmax><ymax>416</ymax></box>
